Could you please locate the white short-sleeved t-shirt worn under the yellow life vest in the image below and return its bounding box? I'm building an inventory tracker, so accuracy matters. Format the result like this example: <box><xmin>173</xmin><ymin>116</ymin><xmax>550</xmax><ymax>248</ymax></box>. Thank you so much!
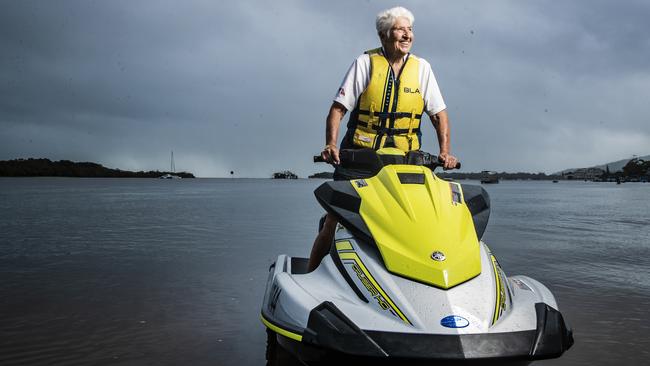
<box><xmin>334</xmin><ymin>53</ymin><xmax>447</xmax><ymax>116</ymax></box>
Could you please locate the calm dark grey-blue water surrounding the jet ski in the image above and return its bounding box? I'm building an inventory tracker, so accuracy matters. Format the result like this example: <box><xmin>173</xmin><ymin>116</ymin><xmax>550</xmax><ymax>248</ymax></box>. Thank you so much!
<box><xmin>0</xmin><ymin>178</ymin><xmax>650</xmax><ymax>365</ymax></box>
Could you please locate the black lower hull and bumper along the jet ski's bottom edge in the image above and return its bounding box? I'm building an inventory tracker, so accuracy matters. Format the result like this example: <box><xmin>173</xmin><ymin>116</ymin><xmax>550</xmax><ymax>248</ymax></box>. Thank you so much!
<box><xmin>262</xmin><ymin>256</ymin><xmax>573</xmax><ymax>364</ymax></box>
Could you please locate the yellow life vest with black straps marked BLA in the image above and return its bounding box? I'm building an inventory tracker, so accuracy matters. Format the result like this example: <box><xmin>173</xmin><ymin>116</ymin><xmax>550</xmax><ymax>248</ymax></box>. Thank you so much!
<box><xmin>348</xmin><ymin>48</ymin><xmax>424</xmax><ymax>151</ymax></box>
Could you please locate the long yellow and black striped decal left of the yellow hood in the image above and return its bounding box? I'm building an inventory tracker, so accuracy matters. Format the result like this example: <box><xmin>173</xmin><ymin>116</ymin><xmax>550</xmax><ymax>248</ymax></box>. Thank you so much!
<box><xmin>336</xmin><ymin>241</ymin><xmax>413</xmax><ymax>325</ymax></box>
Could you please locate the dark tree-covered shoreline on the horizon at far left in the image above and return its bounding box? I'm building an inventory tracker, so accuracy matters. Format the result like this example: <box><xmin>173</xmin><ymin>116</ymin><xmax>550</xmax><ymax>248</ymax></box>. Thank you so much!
<box><xmin>0</xmin><ymin>158</ymin><xmax>195</xmax><ymax>178</ymax></box>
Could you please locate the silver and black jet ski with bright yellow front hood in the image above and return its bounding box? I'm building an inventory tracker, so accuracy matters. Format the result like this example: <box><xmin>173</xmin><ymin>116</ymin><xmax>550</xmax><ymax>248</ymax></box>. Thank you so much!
<box><xmin>261</xmin><ymin>148</ymin><xmax>573</xmax><ymax>365</ymax></box>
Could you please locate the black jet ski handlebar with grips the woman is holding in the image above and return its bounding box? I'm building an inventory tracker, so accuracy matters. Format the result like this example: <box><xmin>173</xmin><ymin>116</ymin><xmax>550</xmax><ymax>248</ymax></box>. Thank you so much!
<box><xmin>314</xmin><ymin>149</ymin><xmax>461</xmax><ymax>171</ymax></box>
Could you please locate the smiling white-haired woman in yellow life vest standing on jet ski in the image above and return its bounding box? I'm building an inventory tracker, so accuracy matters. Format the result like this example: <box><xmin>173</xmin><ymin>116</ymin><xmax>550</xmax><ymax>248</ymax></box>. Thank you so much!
<box><xmin>309</xmin><ymin>7</ymin><xmax>457</xmax><ymax>271</ymax></box>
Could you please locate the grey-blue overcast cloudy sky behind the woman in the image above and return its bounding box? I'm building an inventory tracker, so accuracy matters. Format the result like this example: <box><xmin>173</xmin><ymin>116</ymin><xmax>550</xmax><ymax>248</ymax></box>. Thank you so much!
<box><xmin>0</xmin><ymin>0</ymin><xmax>650</xmax><ymax>177</ymax></box>
